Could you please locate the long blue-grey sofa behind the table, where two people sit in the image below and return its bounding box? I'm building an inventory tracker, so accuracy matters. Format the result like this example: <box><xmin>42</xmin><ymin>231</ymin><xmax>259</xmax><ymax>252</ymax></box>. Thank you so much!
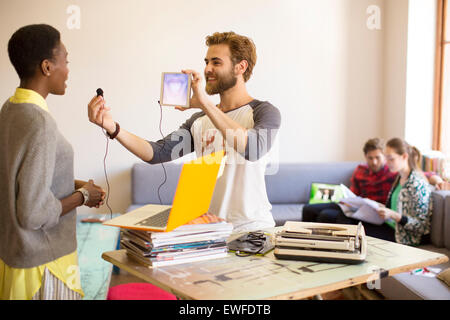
<box><xmin>128</xmin><ymin>162</ymin><xmax>450</xmax><ymax>299</ymax></box>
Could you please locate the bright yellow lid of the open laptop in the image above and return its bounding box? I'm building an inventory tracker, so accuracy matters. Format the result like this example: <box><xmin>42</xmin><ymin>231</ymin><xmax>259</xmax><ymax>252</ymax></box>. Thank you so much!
<box><xmin>165</xmin><ymin>150</ymin><xmax>225</xmax><ymax>232</ymax></box>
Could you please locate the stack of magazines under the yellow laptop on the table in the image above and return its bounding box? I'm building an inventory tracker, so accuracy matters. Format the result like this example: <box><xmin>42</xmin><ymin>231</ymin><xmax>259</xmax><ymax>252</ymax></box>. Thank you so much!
<box><xmin>120</xmin><ymin>213</ymin><xmax>233</xmax><ymax>267</ymax></box>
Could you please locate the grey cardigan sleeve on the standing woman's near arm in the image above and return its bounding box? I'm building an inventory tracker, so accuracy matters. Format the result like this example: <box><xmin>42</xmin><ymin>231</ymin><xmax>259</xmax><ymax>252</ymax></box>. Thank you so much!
<box><xmin>16</xmin><ymin>114</ymin><xmax>62</xmax><ymax>230</ymax></box>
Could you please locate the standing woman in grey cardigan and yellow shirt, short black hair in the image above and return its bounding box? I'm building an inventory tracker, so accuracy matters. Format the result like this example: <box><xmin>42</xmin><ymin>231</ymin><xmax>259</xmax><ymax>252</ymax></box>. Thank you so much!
<box><xmin>0</xmin><ymin>24</ymin><xmax>105</xmax><ymax>299</ymax></box>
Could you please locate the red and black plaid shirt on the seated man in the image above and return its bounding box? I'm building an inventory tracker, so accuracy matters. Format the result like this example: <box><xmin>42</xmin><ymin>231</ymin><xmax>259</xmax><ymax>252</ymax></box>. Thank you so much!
<box><xmin>350</xmin><ymin>164</ymin><xmax>397</xmax><ymax>204</ymax></box>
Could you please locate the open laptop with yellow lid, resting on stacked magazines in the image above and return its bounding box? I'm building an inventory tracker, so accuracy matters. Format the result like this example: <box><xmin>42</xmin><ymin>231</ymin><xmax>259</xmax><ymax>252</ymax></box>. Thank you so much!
<box><xmin>103</xmin><ymin>150</ymin><xmax>225</xmax><ymax>232</ymax></box>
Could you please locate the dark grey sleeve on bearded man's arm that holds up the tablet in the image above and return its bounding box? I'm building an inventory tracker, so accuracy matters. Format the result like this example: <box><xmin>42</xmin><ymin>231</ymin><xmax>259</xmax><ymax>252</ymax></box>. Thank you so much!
<box><xmin>244</xmin><ymin>101</ymin><xmax>281</xmax><ymax>161</ymax></box>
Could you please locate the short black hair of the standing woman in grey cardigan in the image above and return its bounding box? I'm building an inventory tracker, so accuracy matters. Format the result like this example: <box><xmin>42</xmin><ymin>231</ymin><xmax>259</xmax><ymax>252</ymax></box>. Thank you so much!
<box><xmin>8</xmin><ymin>24</ymin><xmax>61</xmax><ymax>80</ymax></box>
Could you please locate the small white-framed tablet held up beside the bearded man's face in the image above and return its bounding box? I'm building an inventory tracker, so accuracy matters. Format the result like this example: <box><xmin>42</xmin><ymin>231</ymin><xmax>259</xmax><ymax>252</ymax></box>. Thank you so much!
<box><xmin>160</xmin><ymin>72</ymin><xmax>191</xmax><ymax>108</ymax></box>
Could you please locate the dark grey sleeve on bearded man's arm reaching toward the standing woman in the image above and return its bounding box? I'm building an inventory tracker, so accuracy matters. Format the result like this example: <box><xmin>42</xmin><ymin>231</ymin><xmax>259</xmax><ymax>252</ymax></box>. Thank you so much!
<box><xmin>148</xmin><ymin>112</ymin><xmax>205</xmax><ymax>164</ymax></box>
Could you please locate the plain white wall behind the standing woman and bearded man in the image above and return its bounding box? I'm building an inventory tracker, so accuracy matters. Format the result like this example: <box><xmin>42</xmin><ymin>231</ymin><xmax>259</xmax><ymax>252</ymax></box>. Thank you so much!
<box><xmin>0</xmin><ymin>0</ymin><xmax>400</xmax><ymax>212</ymax></box>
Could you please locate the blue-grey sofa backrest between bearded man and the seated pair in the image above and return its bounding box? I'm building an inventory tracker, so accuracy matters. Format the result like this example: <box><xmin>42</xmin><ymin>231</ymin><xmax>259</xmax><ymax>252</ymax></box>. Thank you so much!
<box><xmin>265</xmin><ymin>162</ymin><xmax>360</xmax><ymax>204</ymax></box>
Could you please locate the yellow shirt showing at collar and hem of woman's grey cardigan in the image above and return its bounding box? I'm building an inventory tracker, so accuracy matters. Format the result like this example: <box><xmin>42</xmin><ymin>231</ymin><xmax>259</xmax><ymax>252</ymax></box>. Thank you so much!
<box><xmin>0</xmin><ymin>88</ymin><xmax>84</xmax><ymax>300</ymax></box>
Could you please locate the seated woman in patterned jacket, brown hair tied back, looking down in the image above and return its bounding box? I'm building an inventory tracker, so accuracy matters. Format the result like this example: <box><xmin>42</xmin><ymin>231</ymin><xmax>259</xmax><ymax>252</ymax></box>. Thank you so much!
<box><xmin>336</xmin><ymin>138</ymin><xmax>431</xmax><ymax>246</ymax></box>
